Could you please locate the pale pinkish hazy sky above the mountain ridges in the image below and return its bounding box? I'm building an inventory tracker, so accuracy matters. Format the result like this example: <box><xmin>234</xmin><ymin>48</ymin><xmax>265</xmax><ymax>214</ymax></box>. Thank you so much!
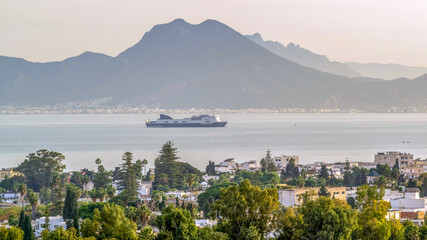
<box><xmin>0</xmin><ymin>0</ymin><xmax>427</xmax><ymax>66</ymax></box>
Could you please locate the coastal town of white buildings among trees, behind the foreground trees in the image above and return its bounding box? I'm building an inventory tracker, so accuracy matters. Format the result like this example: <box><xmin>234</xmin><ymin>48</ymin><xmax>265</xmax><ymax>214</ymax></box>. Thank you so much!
<box><xmin>0</xmin><ymin>142</ymin><xmax>427</xmax><ymax>239</ymax></box>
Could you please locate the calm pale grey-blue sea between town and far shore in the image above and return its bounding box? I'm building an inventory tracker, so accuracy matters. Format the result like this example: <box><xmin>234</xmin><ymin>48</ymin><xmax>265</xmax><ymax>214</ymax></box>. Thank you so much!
<box><xmin>0</xmin><ymin>114</ymin><xmax>427</xmax><ymax>170</ymax></box>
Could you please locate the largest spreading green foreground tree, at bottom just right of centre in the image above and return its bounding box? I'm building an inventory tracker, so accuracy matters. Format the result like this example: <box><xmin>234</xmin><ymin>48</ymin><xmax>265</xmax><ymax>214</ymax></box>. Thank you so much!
<box><xmin>212</xmin><ymin>180</ymin><xmax>279</xmax><ymax>239</ymax></box>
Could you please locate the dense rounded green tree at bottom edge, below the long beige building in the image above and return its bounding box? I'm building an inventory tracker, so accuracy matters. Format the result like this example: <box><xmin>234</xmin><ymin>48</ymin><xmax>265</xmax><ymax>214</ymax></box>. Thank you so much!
<box><xmin>298</xmin><ymin>196</ymin><xmax>357</xmax><ymax>239</ymax></box>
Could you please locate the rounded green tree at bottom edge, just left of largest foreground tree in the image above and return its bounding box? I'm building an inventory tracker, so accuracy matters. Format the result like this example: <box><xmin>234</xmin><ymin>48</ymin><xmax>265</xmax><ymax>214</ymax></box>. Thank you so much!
<box><xmin>156</xmin><ymin>205</ymin><xmax>197</xmax><ymax>240</ymax></box>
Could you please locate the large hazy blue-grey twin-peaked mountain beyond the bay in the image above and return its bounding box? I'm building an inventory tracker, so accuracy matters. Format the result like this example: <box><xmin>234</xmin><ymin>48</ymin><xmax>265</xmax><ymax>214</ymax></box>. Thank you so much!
<box><xmin>0</xmin><ymin>19</ymin><xmax>427</xmax><ymax>109</ymax></box>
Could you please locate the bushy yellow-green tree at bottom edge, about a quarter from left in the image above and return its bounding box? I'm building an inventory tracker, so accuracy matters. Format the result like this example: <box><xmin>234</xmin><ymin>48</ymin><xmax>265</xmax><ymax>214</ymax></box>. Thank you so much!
<box><xmin>81</xmin><ymin>204</ymin><xmax>137</xmax><ymax>240</ymax></box>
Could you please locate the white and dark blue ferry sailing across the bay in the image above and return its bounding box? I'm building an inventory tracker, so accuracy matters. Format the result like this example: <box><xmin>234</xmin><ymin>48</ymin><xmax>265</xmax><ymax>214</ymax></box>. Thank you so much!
<box><xmin>145</xmin><ymin>114</ymin><xmax>227</xmax><ymax>128</ymax></box>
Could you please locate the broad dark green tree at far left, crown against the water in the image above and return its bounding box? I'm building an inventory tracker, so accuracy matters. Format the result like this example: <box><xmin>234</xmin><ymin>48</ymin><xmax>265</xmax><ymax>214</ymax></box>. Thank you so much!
<box><xmin>15</xmin><ymin>149</ymin><xmax>65</xmax><ymax>192</ymax></box>
